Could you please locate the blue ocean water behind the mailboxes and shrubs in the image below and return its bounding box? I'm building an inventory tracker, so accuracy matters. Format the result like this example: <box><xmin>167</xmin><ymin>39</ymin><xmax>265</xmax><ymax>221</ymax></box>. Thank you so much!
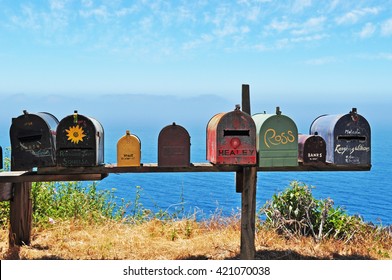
<box><xmin>0</xmin><ymin>122</ymin><xmax>392</xmax><ymax>225</ymax></box>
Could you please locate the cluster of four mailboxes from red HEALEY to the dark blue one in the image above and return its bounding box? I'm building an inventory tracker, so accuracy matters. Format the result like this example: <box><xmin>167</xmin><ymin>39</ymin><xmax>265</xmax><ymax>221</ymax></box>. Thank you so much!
<box><xmin>207</xmin><ymin>107</ymin><xmax>371</xmax><ymax>167</ymax></box>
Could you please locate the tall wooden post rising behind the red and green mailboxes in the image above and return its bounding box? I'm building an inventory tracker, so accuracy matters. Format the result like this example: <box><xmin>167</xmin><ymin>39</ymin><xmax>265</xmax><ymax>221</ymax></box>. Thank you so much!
<box><xmin>237</xmin><ymin>85</ymin><xmax>257</xmax><ymax>260</ymax></box>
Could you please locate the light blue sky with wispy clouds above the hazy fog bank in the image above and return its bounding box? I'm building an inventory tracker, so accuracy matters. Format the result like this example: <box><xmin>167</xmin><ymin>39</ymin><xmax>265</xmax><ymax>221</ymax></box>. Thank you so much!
<box><xmin>0</xmin><ymin>0</ymin><xmax>392</xmax><ymax>124</ymax></box>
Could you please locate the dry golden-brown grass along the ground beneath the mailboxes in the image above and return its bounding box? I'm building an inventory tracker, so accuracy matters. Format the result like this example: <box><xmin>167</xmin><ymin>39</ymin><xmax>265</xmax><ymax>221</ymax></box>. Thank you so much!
<box><xmin>0</xmin><ymin>219</ymin><xmax>392</xmax><ymax>260</ymax></box>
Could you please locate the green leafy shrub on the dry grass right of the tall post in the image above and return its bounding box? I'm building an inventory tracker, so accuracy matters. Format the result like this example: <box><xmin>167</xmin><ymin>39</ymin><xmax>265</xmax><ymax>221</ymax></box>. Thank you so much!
<box><xmin>260</xmin><ymin>181</ymin><xmax>364</xmax><ymax>241</ymax></box>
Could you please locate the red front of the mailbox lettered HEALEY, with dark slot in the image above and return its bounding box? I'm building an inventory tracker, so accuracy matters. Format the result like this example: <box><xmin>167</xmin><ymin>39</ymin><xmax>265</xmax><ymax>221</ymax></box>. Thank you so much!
<box><xmin>215</xmin><ymin>110</ymin><xmax>257</xmax><ymax>165</ymax></box>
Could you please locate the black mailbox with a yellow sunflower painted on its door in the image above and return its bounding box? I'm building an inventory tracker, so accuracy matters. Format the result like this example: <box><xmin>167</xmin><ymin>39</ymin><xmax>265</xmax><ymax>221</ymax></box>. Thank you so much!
<box><xmin>56</xmin><ymin>111</ymin><xmax>104</xmax><ymax>167</ymax></box>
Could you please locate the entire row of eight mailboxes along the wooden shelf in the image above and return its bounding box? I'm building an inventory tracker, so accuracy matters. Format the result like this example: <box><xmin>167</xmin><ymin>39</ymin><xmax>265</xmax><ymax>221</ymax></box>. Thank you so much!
<box><xmin>1</xmin><ymin>106</ymin><xmax>371</xmax><ymax>170</ymax></box>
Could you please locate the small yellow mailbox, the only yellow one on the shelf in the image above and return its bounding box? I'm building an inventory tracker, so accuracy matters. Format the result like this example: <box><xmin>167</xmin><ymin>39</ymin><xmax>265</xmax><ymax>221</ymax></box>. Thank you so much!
<box><xmin>117</xmin><ymin>130</ymin><xmax>141</xmax><ymax>166</ymax></box>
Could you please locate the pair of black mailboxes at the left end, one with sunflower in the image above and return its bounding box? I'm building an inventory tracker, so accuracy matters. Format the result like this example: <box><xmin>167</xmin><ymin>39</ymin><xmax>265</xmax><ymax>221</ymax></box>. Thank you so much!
<box><xmin>10</xmin><ymin>111</ymin><xmax>104</xmax><ymax>170</ymax></box>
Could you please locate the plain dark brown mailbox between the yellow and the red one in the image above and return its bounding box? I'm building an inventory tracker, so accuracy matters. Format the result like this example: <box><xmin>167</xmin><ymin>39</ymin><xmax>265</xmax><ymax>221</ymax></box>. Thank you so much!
<box><xmin>158</xmin><ymin>123</ymin><xmax>191</xmax><ymax>167</ymax></box>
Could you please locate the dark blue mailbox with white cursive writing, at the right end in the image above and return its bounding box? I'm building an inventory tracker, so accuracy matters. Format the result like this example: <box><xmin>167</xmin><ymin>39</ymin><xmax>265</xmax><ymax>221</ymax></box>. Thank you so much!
<box><xmin>310</xmin><ymin>108</ymin><xmax>371</xmax><ymax>165</ymax></box>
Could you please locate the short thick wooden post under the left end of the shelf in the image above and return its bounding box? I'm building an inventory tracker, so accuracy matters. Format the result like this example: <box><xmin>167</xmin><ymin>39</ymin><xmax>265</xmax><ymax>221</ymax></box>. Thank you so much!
<box><xmin>9</xmin><ymin>182</ymin><xmax>33</xmax><ymax>247</ymax></box>
